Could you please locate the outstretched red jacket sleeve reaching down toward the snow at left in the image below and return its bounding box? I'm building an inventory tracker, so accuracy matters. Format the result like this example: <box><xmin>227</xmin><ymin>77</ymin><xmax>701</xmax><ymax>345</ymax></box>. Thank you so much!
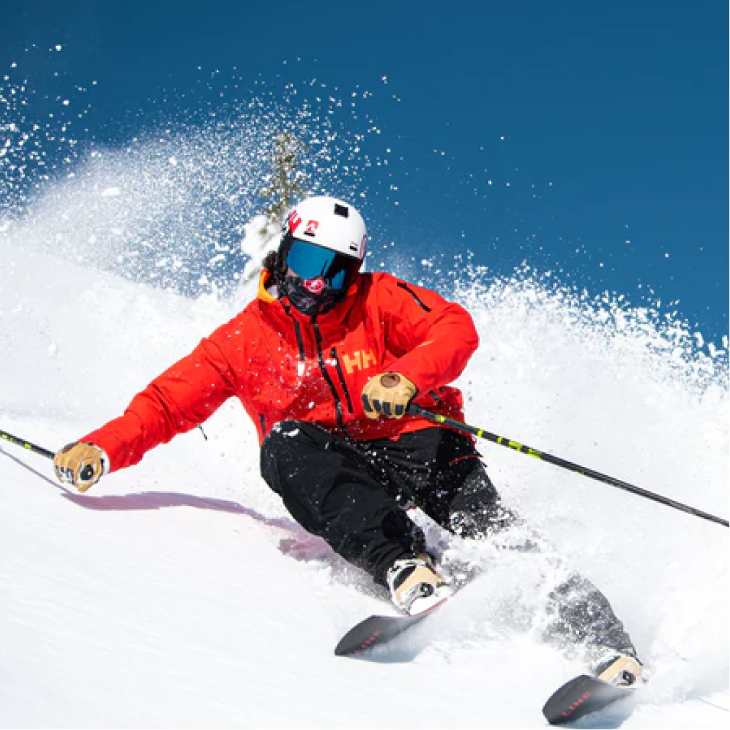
<box><xmin>80</xmin><ymin>339</ymin><xmax>233</xmax><ymax>471</ymax></box>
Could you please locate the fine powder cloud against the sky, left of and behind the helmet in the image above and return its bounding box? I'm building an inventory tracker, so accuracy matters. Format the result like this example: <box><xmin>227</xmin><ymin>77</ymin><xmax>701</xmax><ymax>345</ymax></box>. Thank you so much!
<box><xmin>0</xmin><ymin>57</ymin><xmax>398</xmax><ymax>295</ymax></box>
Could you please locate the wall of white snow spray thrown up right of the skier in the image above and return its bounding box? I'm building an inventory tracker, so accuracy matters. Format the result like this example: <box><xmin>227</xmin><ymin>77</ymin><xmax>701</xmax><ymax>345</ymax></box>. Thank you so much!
<box><xmin>457</xmin><ymin>269</ymin><xmax>730</xmax><ymax>698</ymax></box>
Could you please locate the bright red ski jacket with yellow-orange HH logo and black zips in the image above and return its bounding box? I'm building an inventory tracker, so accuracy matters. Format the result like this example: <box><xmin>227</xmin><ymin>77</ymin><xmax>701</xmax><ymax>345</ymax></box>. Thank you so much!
<box><xmin>81</xmin><ymin>272</ymin><xmax>478</xmax><ymax>471</ymax></box>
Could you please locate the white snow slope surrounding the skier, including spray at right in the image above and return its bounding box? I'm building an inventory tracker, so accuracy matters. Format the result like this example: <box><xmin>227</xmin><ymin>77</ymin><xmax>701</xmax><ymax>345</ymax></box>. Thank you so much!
<box><xmin>0</xmin><ymin>238</ymin><xmax>730</xmax><ymax>730</ymax></box>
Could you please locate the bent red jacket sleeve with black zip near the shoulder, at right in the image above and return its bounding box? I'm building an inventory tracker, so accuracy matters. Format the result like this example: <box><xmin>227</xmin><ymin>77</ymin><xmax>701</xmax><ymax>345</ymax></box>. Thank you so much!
<box><xmin>376</xmin><ymin>278</ymin><xmax>479</xmax><ymax>394</ymax></box>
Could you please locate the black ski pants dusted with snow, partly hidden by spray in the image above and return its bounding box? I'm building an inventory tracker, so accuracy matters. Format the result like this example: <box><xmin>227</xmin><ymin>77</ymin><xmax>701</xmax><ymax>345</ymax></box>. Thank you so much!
<box><xmin>261</xmin><ymin>421</ymin><xmax>631</xmax><ymax>651</ymax></box>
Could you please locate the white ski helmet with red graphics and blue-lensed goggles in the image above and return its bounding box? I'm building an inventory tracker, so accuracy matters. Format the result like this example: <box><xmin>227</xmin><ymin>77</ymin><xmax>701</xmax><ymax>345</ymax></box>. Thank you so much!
<box><xmin>277</xmin><ymin>195</ymin><xmax>367</xmax><ymax>293</ymax></box>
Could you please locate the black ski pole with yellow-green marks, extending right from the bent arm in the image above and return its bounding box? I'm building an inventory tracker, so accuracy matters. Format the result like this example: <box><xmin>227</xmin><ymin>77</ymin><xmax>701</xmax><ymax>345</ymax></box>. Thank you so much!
<box><xmin>408</xmin><ymin>403</ymin><xmax>730</xmax><ymax>527</ymax></box>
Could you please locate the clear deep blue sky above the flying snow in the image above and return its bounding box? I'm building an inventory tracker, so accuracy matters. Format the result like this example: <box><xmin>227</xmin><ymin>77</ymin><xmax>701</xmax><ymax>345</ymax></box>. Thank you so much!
<box><xmin>0</xmin><ymin>0</ymin><xmax>730</xmax><ymax>339</ymax></box>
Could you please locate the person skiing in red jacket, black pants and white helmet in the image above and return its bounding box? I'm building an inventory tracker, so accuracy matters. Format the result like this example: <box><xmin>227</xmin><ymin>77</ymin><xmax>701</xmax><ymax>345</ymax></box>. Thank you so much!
<box><xmin>54</xmin><ymin>196</ymin><xmax>641</xmax><ymax>684</ymax></box>
